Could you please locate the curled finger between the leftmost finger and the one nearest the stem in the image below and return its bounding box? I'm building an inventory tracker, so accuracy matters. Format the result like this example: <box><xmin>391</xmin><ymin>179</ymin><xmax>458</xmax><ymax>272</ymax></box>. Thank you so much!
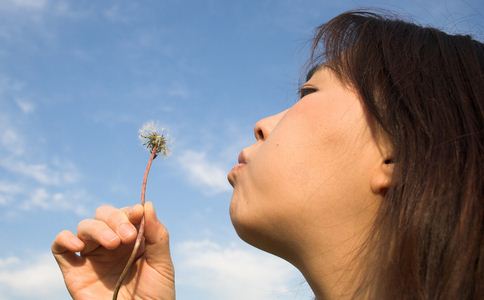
<box><xmin>77</xmin><ymin>219</ymin><xmax>121</xmax><ymax>250</ymax></box>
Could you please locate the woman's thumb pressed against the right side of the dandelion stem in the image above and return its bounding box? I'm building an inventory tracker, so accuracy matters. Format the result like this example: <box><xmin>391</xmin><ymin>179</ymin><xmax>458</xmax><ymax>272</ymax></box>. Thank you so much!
<box><xmin>144</xmin><ymin>202</ymin><xmax>174</xmax><ymax>281</ymax></box>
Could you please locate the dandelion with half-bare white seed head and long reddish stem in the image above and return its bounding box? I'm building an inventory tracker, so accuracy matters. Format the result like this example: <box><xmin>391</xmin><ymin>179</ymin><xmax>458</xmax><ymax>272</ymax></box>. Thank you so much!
<box><xmin>113</xmin><ymin>121</ymin><xmax>169</xmax><ymax>300</ymax></box>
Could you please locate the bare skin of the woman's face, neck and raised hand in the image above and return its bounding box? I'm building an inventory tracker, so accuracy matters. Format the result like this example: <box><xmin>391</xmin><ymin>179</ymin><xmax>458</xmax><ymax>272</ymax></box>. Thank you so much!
<box><xmin>52</xmin><ymin>68</ymin><xmax>391</xmax><ymax>300</ymax></box>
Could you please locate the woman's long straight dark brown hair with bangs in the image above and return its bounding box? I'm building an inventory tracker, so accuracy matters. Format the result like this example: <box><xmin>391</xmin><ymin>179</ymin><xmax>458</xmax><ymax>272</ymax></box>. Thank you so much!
<box><xmin>309</xmin><ymin>11</ymin><xmax>484</xmax><ymax>299</ymax></box>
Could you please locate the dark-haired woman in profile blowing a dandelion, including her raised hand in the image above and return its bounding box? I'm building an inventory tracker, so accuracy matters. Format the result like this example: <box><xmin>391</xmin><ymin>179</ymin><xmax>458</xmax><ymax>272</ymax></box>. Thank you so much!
<box><xmin>52</xmin><ymin>11</ymin><xmax>484</xmax><ymax>299</ymax></box>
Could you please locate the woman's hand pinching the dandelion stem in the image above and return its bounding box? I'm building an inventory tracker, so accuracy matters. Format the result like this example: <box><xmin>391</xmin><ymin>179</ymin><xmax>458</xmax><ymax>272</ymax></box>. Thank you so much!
<box><xmin>52</xmin><ymin>202</ymin><xmax>175</xmax><ymax>300</ymax></box>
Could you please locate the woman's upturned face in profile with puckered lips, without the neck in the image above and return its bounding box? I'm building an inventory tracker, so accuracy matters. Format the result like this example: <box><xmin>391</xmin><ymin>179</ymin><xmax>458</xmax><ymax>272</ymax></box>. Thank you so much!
<box><xmin>228</xmin><ymin>68</ymin><xmax>385</xmax><ymax>258</ymax></box>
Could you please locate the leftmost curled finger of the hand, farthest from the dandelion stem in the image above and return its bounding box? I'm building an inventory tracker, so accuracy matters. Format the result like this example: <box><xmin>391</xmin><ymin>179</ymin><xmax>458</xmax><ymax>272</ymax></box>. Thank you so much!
<box><xmin>51</xmin><ymin>230</ymin><xmax>85</xmax><ymax>269</ymax></box>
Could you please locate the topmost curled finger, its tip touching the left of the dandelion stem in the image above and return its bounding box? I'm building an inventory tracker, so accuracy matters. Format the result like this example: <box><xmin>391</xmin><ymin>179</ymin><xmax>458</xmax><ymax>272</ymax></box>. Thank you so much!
<box><xmin>95</xmin><ymin>205</ymin><xmax>137</xmax><ymax>244</ymax></box>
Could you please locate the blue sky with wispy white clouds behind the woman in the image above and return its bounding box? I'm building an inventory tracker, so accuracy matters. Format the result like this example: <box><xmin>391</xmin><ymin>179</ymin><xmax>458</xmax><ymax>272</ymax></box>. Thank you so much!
<box><xmin>0</xmin><ymin>0</ymin><xmax>484</xmax><ymax>300</ymax></box>
